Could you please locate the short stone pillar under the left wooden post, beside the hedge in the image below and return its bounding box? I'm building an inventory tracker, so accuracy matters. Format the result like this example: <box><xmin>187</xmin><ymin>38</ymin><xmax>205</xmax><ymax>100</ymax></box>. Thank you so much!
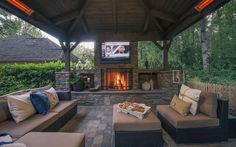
<box><xmin>55</xmin><ymin>71</ymin><xmax>71</xmax><ymax>91</ymax></box>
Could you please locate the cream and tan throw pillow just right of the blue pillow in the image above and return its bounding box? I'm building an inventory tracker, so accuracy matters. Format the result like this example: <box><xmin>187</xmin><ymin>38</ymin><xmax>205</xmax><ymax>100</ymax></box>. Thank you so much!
<box><xmin>44</xmin><ymin>87</ymin><xmax>59</xmax><ymax>109</ymax></box>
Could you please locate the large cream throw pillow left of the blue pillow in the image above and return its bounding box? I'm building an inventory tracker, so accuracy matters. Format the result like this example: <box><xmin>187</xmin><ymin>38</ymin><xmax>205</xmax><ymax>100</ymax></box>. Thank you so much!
<box><xmin>7</xmin><ymin>92</ymin><xmax>36</xmax><ymax>123</ymax></box>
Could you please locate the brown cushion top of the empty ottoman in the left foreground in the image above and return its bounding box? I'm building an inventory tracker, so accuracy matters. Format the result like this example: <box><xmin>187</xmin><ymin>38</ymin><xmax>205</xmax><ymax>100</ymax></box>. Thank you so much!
<box><xmin>16</xmin><ymin>132</ymin><xmax>85</xmax><ymax>147</ymax></box>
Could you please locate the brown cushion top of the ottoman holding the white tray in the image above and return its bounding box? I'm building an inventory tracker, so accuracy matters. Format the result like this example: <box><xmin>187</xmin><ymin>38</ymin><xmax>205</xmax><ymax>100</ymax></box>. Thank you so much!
<box><xmin>113</xmin><ymin>105</ymin><xmax>161</xmax><ymax>131</ymax></box>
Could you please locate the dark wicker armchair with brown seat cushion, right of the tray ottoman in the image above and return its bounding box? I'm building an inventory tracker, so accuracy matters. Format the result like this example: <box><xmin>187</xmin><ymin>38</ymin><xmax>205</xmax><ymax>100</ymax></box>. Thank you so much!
<box><xmin>157</xmin><ymin>92</ymin><xmax>228</xmax><ymax>144</ymax></box>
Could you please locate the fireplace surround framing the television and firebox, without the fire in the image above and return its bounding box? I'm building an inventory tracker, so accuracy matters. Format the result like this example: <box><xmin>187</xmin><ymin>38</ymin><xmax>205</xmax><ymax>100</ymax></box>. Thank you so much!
<box><xmin>95</xmin><ymin>41</ymin><xmax>138</xmax><ymax>89</ymax></box>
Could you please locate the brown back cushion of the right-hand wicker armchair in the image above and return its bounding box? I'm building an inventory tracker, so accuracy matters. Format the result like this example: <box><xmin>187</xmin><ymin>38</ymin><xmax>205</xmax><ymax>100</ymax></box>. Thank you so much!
<box><xmin>198</xmin><ymin>92</ymin><xmax>217</xmax><ymax>118</ymax></box>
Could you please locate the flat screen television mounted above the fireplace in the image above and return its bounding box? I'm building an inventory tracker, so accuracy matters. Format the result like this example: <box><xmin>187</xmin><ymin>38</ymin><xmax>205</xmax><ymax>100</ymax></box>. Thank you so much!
<box><xmin>101</xmin><ymin>42</ymin><xmax>130</xmax><ymax>63</ymax></box>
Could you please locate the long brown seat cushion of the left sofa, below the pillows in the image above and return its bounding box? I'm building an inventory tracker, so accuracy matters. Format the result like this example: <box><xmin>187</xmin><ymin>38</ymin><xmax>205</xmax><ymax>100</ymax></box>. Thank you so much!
<box><xmin>0</xmin><ymin>112</ymin><xmax>59</xmax><ymax>138</ymax></box>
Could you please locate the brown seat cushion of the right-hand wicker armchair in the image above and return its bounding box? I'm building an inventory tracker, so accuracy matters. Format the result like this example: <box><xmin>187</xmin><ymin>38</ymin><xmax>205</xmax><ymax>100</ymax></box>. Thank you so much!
<box><xmin>157</xmin><ymin>105</ymin><xmax>219</xmax><ymax>128</ymax></box>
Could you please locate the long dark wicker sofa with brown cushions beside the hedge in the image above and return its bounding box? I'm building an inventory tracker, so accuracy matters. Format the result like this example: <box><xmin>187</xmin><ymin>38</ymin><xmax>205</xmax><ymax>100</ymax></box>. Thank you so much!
<box><xmin>0</xmin><ymin>86</ymin><xmax>77</xmax><ymax>140</ymax></box>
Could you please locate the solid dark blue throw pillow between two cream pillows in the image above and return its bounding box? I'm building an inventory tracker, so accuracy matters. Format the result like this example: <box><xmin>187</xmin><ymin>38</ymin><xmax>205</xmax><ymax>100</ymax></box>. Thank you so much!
<box><xmin>30</xmin><ymin>91</ymin><xmax>50</xmax><ymax>115</ymax></box>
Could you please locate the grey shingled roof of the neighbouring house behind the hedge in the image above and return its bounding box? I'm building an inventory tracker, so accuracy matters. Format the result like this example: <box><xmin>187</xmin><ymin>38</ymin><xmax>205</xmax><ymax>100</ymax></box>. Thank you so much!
<box><xmin>0</xmin><ymin>35</ymin><xmax>77</xmax><ymax>63</ymax></box>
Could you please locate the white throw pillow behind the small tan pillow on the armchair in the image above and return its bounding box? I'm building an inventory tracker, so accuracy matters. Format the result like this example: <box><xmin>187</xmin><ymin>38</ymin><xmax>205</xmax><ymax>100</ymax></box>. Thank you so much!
<box><xmin>179</xmin><ymin>84</ymin><xmax>201</xmax><ymax>115</ymax></box>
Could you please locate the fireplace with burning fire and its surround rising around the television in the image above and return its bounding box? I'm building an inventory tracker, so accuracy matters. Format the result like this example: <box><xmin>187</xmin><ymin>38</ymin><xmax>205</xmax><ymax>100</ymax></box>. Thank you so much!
<box><xmin>95</xmin><ymin>42</ymin><xmax>138</xmax><ymax>90</ymax></box>
